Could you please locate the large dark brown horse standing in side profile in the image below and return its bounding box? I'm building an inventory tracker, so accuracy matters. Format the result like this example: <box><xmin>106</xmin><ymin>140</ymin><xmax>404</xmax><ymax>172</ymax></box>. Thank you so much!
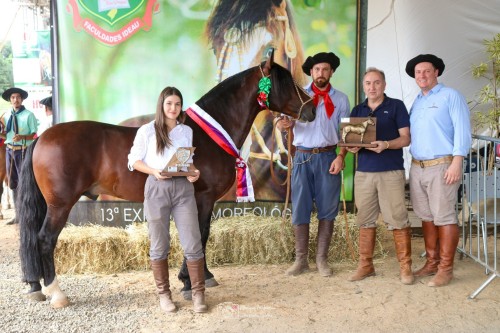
<box><xmin>16</xmin><ymin>56</ymin><xmax>315</xmax><ymax>308</ymax></box>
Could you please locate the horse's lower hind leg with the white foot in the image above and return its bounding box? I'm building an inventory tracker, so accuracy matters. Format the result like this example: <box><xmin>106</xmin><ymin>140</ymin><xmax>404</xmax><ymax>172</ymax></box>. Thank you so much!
<box><xmin>38</xmin><ymin>206</ymin><xmax>69</xmax><ymax>309</ymax></box>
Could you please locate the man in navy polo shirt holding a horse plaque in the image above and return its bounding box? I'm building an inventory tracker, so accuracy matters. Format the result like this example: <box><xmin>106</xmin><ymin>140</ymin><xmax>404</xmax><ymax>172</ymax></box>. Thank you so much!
<box><xmin>347</xmin><ymin>67</ymin><xmax>414</xmax><ymax>284</ymax></box>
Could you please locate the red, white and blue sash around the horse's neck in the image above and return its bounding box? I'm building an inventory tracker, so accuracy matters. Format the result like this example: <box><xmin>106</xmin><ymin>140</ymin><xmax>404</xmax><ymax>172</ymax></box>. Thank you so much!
<box><xmin>186</xmin><ymin>104</ymin><xmax>255</xmax><ymax>202</ymax></box>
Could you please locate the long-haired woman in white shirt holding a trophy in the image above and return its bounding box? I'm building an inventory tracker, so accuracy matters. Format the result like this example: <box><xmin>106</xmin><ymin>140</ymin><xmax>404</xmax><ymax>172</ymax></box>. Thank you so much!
<box><xmin>128</xmin><ymin>87</ymin><xmax>207</xmax><ymax>313</ymax></box>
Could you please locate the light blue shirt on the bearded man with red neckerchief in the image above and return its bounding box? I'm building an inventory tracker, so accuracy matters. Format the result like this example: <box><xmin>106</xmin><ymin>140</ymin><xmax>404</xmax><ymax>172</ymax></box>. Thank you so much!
<box><xmin>293</xmin><ymin>83</ymin><xmax>351</xmax><ymax>148</ymax></box>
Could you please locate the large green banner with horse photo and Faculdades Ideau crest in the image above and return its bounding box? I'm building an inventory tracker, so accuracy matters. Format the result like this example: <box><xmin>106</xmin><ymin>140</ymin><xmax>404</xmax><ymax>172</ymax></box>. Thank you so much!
<box><xmin>53</xmin><ymin>0</ymin><xmax>359</xmax><ymax>223</ymax></box>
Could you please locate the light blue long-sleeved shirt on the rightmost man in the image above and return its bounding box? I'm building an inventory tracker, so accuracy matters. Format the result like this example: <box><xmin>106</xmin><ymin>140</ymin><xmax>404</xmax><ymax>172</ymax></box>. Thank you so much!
<box><xmin>410</xmin><ymin>84</ymin><xmax>472</xmax><ymax>160</ymax></box>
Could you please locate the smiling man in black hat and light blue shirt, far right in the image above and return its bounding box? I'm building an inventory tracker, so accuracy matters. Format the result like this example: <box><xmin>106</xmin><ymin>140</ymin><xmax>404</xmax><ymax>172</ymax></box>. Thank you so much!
<box><xmin>406</xmin><ymin>54</ymin><xmax>471</xmax><ymax>287</ymax></box>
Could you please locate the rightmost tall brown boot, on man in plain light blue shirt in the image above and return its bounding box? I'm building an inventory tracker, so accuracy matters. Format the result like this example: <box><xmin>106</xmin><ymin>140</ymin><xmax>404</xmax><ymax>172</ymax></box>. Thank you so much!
<box><xmin>427</xmin><ymin>224</ymin><xmax>460</xmax><ymax>287</ymax></box>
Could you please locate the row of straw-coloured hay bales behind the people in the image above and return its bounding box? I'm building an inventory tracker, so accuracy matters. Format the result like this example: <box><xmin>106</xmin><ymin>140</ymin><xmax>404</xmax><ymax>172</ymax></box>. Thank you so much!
<box><xmin>54</xmin><ymin>213</ymin><xmax>386</xmax><ymax>274</ymax></box>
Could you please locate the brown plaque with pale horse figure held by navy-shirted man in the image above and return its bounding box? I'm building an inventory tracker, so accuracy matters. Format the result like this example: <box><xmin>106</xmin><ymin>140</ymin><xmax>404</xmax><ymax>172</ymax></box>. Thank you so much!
<box><xmin>337</xmin><ymin>117</ymin><xmax>377</xmax><ymax>148</ymax></box>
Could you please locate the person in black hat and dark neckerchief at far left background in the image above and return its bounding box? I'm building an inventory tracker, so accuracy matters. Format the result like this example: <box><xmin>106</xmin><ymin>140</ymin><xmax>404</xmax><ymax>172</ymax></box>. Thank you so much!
<box><xmin>0</xmin><ymin>87</ymin><xmax>38</xmax><ymax>224</ymax></box>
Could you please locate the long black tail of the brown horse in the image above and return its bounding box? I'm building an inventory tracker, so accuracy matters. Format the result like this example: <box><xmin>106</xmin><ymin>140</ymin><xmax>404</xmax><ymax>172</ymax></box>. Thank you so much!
<box><xmin>15</xmin><ymin>139</ymin><xmax>47</xmax><ymax>283</ymax></box>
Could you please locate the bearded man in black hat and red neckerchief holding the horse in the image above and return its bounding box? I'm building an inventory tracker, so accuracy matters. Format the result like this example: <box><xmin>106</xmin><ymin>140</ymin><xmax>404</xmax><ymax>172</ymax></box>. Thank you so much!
<box><xmin>277</xmin><ymin>52</ymin><xmax>350</xmax><ymax>276</ymax></box>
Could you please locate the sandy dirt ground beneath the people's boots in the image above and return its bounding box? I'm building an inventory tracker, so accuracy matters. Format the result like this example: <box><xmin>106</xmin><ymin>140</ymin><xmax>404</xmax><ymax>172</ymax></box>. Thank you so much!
<box><xmin>0</xmin><ymin>208</ymin><xmax>500</xmax><ymax>333</ymax></box>
